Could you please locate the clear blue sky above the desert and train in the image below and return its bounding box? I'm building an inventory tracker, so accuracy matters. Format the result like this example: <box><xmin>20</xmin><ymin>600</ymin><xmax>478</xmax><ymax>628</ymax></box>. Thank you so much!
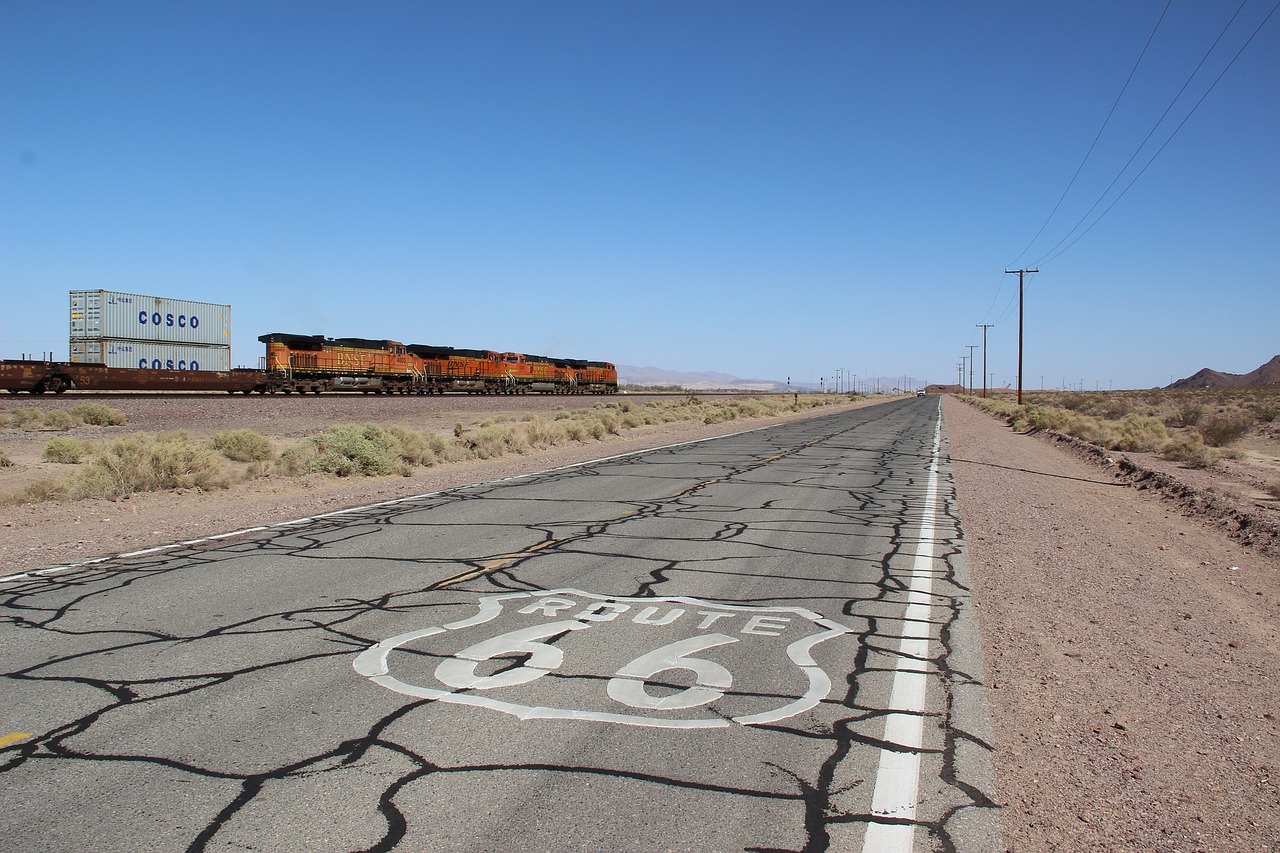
<box><xmin>0</xmin><ymin>0</ymin><xmax>1280</xmax><ymax>388</ymax></box>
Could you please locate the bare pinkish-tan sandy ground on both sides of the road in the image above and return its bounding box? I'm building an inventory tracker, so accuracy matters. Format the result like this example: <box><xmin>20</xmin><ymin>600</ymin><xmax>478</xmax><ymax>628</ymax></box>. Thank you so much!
<box><xmin>0</xmin><ymin>397</ymin><xmax>1280</xmax><ymax>853</ymax></box>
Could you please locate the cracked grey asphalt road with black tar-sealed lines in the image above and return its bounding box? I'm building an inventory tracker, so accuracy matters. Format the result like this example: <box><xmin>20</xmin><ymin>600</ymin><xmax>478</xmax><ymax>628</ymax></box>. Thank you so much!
<box><xmin>0</xmin><ymin>398</ymin><xmax>1002</xmax><ymax>853</ymax></box>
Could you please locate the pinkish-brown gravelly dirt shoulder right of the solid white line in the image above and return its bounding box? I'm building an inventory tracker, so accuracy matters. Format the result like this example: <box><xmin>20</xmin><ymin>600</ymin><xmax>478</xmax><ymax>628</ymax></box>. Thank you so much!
<box><xmin>943</xmin><ymin>398</ymin><xmax>1280</xmax><ymax>852</ymax></box>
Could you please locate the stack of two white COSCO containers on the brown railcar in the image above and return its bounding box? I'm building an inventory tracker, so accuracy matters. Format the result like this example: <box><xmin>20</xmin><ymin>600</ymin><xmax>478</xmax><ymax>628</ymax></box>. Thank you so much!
<box><xmin>70</xmin><ymin>291</ymin><xmax>232</xmax><ymax>370</ymax></box>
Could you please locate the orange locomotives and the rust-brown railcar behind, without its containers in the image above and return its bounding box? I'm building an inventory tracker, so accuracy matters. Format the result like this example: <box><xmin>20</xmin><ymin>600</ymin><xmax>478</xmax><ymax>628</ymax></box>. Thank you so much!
<box><xmin>0</xmin><ymin>332</ymin><xmax>618</xmax><ymax>394</ymax></box>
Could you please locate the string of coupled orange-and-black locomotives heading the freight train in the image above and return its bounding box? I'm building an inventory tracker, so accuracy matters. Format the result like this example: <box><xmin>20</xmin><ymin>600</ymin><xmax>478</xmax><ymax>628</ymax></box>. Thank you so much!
<box><xmin>259</xmin><ymin>333</ymin><xmax>618</xmax><ymax>394</ymax></box>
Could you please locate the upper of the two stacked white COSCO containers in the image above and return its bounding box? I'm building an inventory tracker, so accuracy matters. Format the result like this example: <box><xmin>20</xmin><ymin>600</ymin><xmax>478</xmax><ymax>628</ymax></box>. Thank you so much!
<box><xmin>70</xmin><ymin>291</ymin><xmax>232</xmax><ymax>346</ymax></box>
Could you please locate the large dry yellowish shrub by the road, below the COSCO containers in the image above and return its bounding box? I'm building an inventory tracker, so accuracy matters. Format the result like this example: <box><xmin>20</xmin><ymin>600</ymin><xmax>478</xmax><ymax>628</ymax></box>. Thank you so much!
<box><xmin>69</xmin><ymin>430</ymin><xmax>228</xmax><ymax>498</ymax></box>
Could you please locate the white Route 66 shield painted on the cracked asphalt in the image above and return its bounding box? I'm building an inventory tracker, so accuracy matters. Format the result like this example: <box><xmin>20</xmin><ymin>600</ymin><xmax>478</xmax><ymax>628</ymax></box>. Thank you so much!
<box><xmin>353</xmin><ymin>589</ymin><xmax>852</xmax><ymax>729</ymax></box>
